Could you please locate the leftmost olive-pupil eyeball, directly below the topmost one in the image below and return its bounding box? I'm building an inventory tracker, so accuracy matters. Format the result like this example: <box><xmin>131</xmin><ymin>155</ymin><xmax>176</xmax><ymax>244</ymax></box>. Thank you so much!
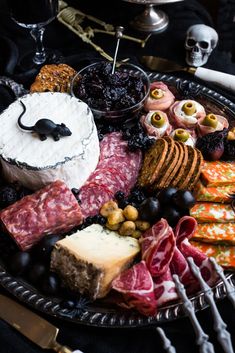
<box><xmin>140</xmin><ymin>110</ymin><xmax>172</xmax><ymax>139</ymax></box>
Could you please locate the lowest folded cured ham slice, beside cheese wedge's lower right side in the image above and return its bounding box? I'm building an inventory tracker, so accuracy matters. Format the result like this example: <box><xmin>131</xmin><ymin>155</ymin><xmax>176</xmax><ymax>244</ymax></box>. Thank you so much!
<box><xmin>112</xmin><ymin>261</ymin><xmax>157</xmax><ymax>316</ymax></box>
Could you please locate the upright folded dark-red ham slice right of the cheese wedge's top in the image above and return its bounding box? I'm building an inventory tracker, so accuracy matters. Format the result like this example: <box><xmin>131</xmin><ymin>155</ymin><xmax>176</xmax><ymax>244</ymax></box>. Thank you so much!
<box><xmin>140</xmin><ymin>218</ymin><xmax>175</xmax><ymax>277</ymax></box>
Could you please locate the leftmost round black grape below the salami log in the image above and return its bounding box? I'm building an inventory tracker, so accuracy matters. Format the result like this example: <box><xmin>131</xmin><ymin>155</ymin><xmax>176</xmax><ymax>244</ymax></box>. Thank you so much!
<box><xmin>8</xmin><ymin>251</ymin><xmax>31</xmax><ymax>276</ymax></box>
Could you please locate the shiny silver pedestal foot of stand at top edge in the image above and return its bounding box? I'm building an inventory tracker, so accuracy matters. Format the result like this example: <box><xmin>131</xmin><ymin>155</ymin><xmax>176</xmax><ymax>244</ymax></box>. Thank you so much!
<box><xmin>124</xmin><ymin>0</ymin><xmax>183</xmax><ymax>33</ymax></box>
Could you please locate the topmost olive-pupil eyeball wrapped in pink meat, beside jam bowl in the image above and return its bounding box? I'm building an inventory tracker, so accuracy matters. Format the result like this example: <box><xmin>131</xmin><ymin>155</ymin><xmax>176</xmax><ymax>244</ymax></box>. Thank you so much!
<box><xmin>144</xmin><ymin>81</ymin><xmax>175</xmax><ymax>112</ymax></box>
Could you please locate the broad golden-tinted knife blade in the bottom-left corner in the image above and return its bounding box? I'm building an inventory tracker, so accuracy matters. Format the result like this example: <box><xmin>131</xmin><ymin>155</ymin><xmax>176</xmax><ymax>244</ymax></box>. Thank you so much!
<box><xmin>0</xmin><ymin>294</ymin><xmax>82</xmax><ymax>353</ymax></box>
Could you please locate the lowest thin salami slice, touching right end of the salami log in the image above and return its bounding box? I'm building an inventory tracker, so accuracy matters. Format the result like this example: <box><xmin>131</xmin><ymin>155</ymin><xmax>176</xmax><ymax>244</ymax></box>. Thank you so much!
<box><xmin>79</xmin><ymin>182</ymin><xmax>113</xmax><ymax>218</ymax></box>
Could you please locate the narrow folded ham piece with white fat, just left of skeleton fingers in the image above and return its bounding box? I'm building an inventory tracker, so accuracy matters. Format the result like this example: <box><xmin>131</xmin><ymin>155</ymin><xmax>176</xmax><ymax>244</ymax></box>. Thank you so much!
<box><xmin>153</xmin><ymin>268</ymin><xmax>178</xmax><ymax>306</ymax></box>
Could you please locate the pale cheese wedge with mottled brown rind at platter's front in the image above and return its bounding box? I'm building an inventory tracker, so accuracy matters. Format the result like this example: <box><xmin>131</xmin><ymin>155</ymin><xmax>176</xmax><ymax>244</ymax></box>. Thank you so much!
<box><xmin>51</xmin><ymin>224</ymin><xmax>140</xmax><ymax>299</ymax></box>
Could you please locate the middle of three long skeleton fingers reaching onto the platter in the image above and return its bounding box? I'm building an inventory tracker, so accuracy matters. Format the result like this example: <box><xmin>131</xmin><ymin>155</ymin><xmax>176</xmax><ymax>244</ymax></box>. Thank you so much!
<box><xmin>187</xmin><ymin>257</ymin><xmax>234</xmax><ymax>353</ymax></box>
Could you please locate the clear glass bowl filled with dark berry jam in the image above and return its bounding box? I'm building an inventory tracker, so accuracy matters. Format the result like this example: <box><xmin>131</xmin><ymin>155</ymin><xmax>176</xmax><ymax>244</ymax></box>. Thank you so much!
<box><xmin>71</xmin><ymin>61</ymin><xmax>150</xmax><ymax>123</ymax></box>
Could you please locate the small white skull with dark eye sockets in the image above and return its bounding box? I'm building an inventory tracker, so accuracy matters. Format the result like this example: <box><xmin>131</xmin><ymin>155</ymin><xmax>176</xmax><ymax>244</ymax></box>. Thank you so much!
<box><xmin>185</xmin><ymin>24</ymin><xmax>218</xmax><ymax>67</ymax></box>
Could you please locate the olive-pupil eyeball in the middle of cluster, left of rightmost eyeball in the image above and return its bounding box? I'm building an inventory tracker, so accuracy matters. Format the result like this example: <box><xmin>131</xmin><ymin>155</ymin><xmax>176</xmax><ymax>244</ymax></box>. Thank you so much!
<box><xmin>169</xmin><ymin>100</ymin><xmax>206</xmax><ymax>129</ymax></box>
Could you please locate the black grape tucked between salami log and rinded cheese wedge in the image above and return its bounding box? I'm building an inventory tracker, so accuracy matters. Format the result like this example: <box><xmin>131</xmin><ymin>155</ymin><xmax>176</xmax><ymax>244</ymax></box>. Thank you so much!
<box><xmin>34</xmin><ymin>234</ymin><xmax>62</xmax><ymax>261</ymax></box>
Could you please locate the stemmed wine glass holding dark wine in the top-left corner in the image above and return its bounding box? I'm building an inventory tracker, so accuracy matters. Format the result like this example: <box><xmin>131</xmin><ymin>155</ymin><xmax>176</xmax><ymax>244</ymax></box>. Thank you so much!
<box><xmin>9</xmin><ymin>0</ymin><xmax>59</xmax><ymax>65</ymax></box>
